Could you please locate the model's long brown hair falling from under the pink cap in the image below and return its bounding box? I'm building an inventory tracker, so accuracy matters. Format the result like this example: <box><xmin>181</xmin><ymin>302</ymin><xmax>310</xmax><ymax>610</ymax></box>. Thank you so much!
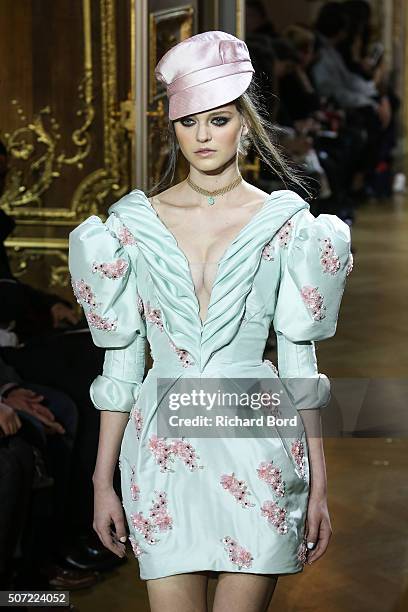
<box><xmin>148</xmin><ymin>76</ymin><xmax>311</xmax><ymax>196</ymax></box>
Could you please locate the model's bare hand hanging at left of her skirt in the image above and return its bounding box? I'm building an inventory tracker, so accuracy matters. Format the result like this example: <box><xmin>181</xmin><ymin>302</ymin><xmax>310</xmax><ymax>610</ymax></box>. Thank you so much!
<box><xmin>92</xmin><ymin>485</ymin><xmax>127</xmax><ymax>558</ymax></box>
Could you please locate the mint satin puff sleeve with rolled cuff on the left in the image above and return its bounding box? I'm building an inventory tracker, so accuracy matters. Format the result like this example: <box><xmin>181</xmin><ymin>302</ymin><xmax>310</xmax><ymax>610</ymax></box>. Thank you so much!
<box><xmin>69</xmin><ymin>213</ymin><xmax>146</xmax><ymax>412</ymax></box>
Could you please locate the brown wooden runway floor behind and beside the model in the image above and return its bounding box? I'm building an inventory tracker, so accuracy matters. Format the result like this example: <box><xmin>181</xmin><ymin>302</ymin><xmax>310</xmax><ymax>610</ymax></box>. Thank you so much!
<box><xmin>71</xmin><ymin>196</ymin><xmax>408</xmax><ymax>612</ymax></box>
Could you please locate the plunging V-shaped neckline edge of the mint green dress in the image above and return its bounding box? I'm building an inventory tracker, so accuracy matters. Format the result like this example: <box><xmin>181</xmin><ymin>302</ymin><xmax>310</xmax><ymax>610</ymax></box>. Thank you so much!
<box><xmin>143</xmin><ymin>192</ymin><xmax>274</xmax><ymax>335</ymax></box>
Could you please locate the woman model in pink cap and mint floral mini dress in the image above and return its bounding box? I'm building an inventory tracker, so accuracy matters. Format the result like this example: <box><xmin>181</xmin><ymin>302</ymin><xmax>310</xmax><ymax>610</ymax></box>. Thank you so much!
<box><xmin>69</xmin><ymin>31</ymin><xmax>352</xmax><ymax>612</ymax></box>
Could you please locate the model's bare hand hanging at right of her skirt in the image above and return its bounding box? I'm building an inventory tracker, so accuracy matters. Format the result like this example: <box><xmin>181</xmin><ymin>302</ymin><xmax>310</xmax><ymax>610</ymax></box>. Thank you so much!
<box><xmin>305</xmin><ymin>493</ymin><xmax>333</xmax><ymax>564</ymax></box>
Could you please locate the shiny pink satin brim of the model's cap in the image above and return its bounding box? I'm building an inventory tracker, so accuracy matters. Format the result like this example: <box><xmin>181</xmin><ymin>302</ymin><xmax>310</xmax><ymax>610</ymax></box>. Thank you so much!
<box><xmin>169</xmin><ymin>71</ymin><xmax>253</xmax><ymax>121</ymax></box>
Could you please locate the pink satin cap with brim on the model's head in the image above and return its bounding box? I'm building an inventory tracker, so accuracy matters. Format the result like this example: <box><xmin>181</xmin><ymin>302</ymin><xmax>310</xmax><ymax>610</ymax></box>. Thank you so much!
<box><xmin>154</xmin><ymin>30</ymin><xmax>255</xmax><ymax>121</ymax></box>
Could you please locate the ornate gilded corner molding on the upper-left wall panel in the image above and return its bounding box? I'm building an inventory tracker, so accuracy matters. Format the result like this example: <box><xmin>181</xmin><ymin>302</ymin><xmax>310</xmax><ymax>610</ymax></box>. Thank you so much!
<box><xmin>0</xmin><ymin>0</ymin><xmax>129</xmax><ymax>225</ymax></box>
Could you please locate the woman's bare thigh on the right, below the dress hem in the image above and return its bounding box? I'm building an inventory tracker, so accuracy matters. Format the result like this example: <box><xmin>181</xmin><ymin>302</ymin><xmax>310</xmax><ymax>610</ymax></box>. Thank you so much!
<box><xmin>213</xmin><ymin>572</ymin><xmax>278</xmax><ymax>612</ymax></box>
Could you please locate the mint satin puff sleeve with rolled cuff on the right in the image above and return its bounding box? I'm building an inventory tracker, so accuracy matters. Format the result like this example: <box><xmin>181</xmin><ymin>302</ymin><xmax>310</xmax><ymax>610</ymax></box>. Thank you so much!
<box><xmin>273</xmin><ymin>210</ymin><xmax>353</xmax><ymax>410</ymax></box>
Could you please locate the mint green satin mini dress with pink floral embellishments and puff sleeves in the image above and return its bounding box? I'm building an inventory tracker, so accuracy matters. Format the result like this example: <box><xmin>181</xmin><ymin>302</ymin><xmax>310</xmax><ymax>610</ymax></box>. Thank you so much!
<box><xmin>69</xmin><ymin>189</ymin><xmax>352</xmax><ymax>580</ymax></box>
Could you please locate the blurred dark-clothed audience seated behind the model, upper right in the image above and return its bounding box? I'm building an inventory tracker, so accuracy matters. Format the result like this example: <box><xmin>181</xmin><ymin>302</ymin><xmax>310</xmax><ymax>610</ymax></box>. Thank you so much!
<box><xmin>246</xmin><ymin>0</ymin><xmax>400</xmax><ymax>220</ymax></box>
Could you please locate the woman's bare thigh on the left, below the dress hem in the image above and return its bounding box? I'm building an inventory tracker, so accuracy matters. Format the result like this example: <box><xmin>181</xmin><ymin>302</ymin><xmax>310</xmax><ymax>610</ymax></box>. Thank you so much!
<box><xmin>147</xmin><ymin>572</ymin><xmax>208</xmax><ymax>612</ymax></box>
